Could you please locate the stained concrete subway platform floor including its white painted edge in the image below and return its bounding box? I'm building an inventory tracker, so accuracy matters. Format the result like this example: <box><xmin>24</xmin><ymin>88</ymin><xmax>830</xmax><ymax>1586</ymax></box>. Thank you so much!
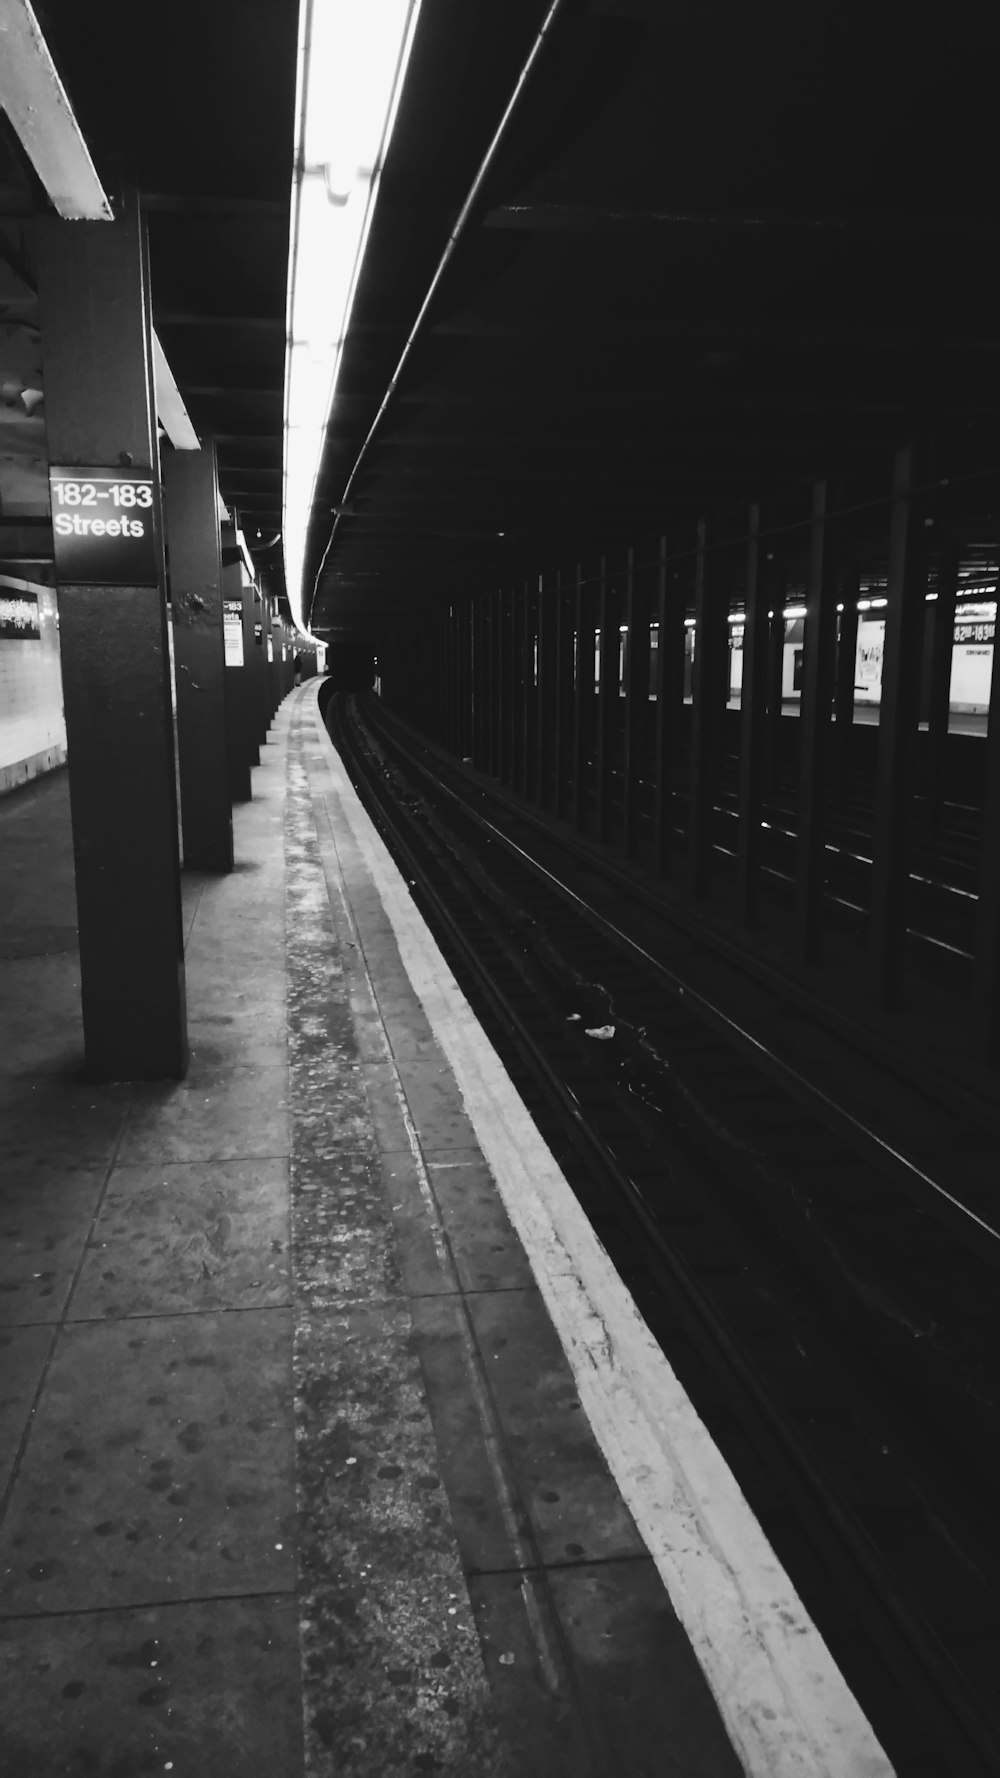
<box><xmin>0</xmin><ymin>679</ymin><xmax>890</xmax><ymax>1778</ymax></box>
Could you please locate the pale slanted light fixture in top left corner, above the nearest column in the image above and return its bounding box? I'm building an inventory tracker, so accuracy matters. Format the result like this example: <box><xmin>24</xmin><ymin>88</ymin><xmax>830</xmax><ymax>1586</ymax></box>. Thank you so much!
<box><xmin>0</xmin><ymin>0</ymin><xmax>112</xmax><ymax>222</ymax></box>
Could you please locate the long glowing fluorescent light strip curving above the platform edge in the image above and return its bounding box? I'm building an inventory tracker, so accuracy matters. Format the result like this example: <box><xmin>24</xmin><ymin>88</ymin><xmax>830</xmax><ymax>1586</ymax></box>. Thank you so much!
<box><xmin>281</xmin><ymin>0</ymin><xmax>420</xmax><ymax>633</ymax></box>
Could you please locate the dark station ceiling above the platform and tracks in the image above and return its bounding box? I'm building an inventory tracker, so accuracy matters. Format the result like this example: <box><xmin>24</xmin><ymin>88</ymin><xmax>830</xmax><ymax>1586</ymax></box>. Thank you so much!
<box><xmin>0</xmin><ymin>0</ymin><xmax>1000</xmax><ymax>647</ymax></box>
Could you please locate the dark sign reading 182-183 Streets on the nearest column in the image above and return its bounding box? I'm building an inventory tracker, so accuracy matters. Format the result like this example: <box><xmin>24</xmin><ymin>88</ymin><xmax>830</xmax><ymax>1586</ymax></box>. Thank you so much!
<box><xmin>48</xmin><ymin>464</ymin><xmax>160</xmax><ymax>587</ymax></box>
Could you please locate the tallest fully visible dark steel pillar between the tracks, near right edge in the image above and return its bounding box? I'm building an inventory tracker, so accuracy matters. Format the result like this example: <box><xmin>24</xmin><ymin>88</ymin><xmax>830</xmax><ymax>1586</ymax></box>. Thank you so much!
<box><xmin>870</xmin><ymin>445</ymin><xmax>927</xmax><ymax>1006</ymax></box>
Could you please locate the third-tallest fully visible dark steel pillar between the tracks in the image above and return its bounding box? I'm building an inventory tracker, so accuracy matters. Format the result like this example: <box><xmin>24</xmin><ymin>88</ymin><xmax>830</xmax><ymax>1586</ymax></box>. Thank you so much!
<box><xmin>737</xmin><ymin>505</ymin><xmax>769</xmax><ymax>926</ymax></box>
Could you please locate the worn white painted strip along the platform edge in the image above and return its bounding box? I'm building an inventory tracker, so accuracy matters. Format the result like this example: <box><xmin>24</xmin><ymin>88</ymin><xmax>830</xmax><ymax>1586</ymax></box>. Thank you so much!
<box><xmin>307</xmin><ymin>689</ymin><xmax>891</xmax><ymax>1778</ymax></box>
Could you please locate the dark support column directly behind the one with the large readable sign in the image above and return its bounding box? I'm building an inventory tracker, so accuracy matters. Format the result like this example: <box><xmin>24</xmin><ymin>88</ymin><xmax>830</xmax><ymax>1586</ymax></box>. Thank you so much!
<box><xmin>164</xmin><ymin>441</ymin><xmax>233</xmax><ymax>871</ymax></box>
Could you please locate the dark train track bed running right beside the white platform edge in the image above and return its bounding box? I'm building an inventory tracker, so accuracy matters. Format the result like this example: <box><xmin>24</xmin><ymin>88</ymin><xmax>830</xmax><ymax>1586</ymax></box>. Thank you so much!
<box><xmin>327</xmin><ymin>699</ymin><xmax>1000</xmax><ymax>1778</ymax></box>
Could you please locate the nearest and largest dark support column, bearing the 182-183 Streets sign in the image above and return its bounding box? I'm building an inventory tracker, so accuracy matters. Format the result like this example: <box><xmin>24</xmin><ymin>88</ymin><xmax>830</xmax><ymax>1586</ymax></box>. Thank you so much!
<box><xmin>36</xmin><ymin>192</ymin><xmax>187</xmax><ymax>1081</ymax></box>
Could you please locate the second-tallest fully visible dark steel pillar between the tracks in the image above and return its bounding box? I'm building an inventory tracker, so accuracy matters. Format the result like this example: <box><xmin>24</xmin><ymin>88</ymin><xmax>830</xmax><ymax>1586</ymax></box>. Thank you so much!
<box><xmin>795</xmin><ymin>480</ymin><xmax>838</xmax><ymax>962</ymax></box>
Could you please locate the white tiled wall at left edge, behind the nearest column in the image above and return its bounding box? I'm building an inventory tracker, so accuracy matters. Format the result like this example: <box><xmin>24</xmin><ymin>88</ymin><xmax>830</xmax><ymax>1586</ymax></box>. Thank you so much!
<box><xmin>0</xmin><ymin>576</ymin><xmax>66</xmax><ymax>795</ymax></box>
